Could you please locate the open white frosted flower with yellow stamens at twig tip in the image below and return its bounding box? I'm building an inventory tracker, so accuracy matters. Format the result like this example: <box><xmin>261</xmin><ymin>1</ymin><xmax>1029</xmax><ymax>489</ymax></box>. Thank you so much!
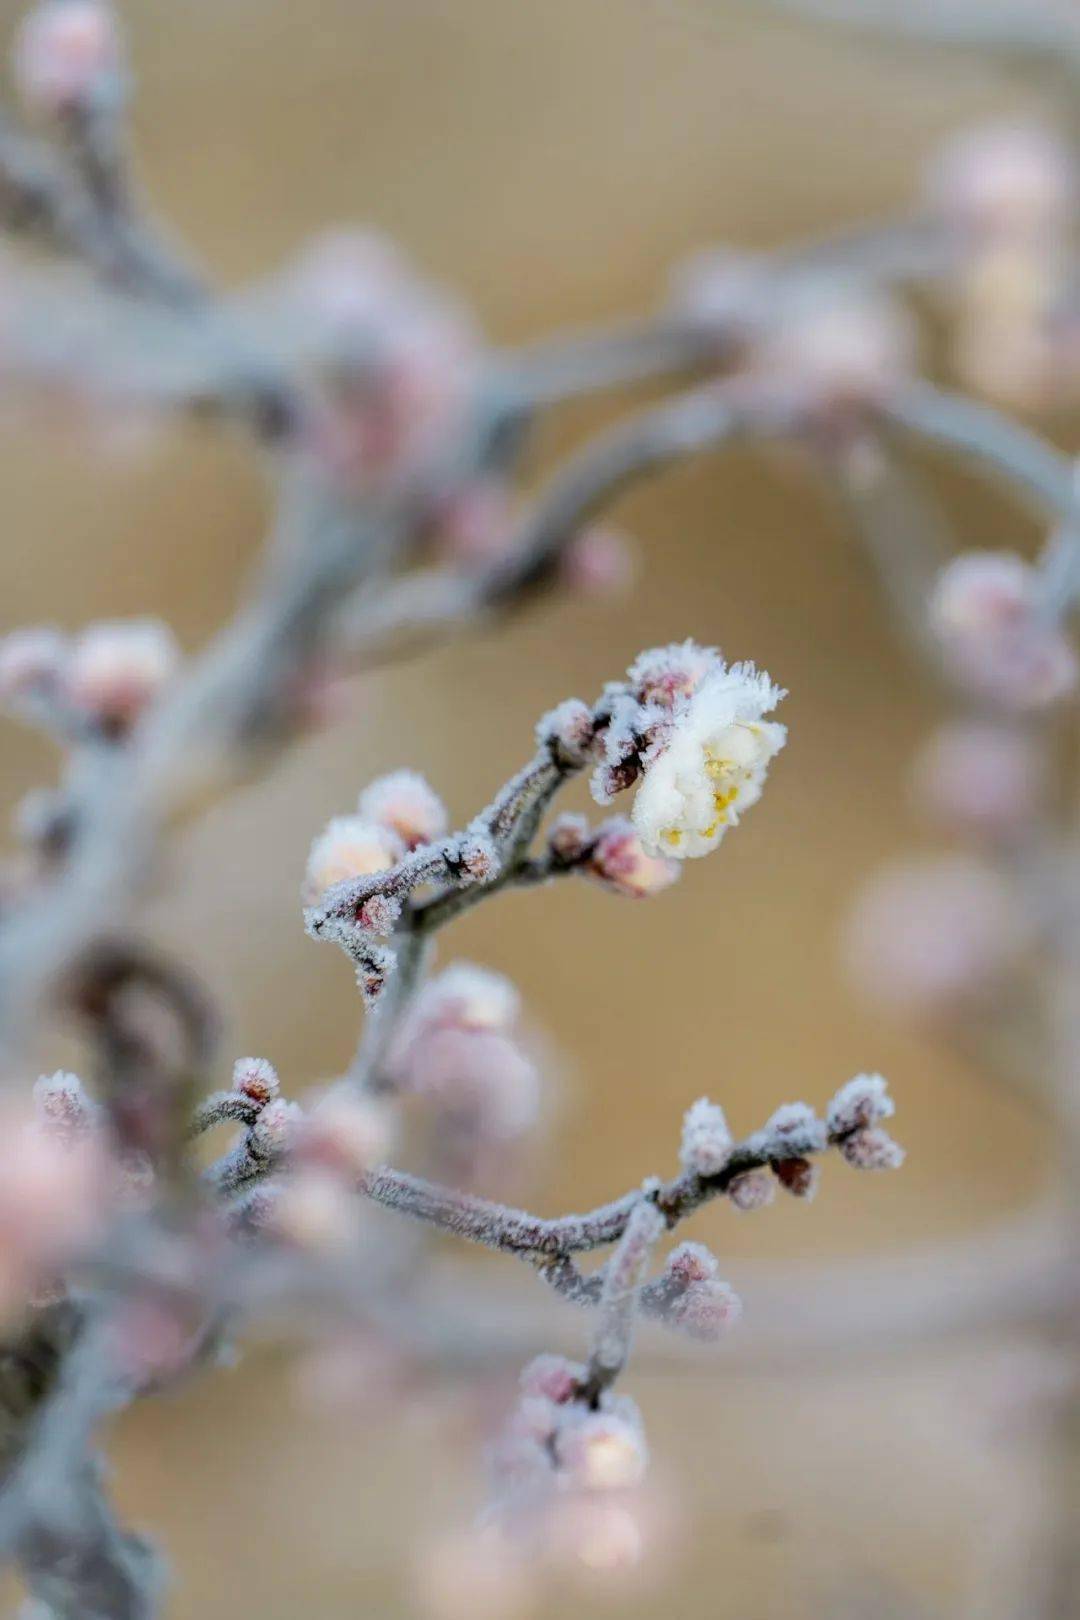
<box><xmin>631</xmin><ymin>663</ymin><xmax>787</xmax><ymax>860</ymax></box>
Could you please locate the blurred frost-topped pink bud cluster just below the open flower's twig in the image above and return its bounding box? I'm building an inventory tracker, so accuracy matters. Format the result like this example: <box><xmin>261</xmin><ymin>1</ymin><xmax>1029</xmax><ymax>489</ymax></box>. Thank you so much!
<box><xmin>387</xmin><ymin>962</ymin><xmax>539</xmax><ymax>1181</ymax></box>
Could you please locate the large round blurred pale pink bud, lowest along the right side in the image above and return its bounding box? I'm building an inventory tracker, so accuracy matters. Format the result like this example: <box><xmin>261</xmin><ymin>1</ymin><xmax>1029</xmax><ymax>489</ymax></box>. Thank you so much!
<box><xmin>844</xmin><ymin>855</ymin><xmax>1027</xmax><ymax>1013</ymax></box>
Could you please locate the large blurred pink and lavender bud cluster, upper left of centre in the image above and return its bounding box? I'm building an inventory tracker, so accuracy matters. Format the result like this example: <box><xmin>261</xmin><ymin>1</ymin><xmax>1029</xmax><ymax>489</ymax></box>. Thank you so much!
<box><xmin>272</xmin><ymin>228</ymin><xmax>481</xmax><ymax>481</ymax></box>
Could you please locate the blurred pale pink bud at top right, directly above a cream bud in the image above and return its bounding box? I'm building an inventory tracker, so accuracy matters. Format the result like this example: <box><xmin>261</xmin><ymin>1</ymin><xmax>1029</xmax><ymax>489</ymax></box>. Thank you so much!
<box><xmin>929</xmin><ymin>122</ymin><xmax>1077</xmax><ymax>240</ymax></box>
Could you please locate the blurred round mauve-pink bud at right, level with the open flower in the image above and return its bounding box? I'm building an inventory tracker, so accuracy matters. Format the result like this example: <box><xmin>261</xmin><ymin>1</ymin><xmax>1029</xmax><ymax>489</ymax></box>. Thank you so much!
<box><xmin>915</xmin><ymin>721</ymin><xmax>1046</xmax><ymax>839</ymax></box>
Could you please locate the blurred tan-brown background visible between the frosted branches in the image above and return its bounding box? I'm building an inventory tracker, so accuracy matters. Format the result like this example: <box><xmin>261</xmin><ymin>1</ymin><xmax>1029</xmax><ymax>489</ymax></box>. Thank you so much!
<box><xmin>0</xmin><ymin>0</ymin><xmax>1070</xmax><ymax>1620</ymax></box>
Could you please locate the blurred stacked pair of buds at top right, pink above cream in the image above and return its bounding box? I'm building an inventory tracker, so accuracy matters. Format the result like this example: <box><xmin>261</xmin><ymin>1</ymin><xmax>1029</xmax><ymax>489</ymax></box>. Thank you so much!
<box><xmin>929</xmin><ymin>123</ymin><xmax>1077</xmax><ymax>408</ymax></box>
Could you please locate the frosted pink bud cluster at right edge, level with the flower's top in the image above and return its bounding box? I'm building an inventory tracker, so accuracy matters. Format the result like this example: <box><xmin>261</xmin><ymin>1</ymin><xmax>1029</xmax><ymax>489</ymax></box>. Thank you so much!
<box><xmin>929</xmin><ymin>551</ymin><xmax>1080</xmax><ymax>713</ymax></box>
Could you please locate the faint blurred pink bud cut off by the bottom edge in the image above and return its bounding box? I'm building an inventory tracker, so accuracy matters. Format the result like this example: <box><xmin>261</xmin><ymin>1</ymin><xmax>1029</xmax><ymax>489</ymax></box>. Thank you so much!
<box><xmin>416</xmin><ymin>1526</ymin><xmax>533</xmax><ymax>1620</ymax></box>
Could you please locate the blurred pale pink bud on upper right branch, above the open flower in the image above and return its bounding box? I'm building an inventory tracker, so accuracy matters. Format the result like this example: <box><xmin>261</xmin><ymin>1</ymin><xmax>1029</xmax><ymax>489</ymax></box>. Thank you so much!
<box><xmin>756</xmin><ymin>300</ymin><xmax>915</xmax><ymax>408</ymax></box>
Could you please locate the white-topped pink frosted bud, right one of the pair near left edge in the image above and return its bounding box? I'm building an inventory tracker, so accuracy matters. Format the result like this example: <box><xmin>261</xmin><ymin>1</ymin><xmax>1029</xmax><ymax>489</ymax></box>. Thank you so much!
<box><xmin>66</xmin><ymin>619</ymin><xmax>180</xmax><ymax>731</ymax></box>
